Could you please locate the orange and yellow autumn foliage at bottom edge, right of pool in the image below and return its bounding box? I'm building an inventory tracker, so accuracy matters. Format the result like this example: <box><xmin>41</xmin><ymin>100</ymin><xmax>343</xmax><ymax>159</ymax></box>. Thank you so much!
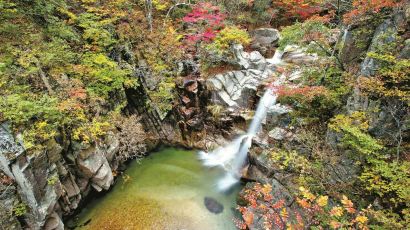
<box><xmin>236</xmin><ymin>183</ymin><xmax>368</xmax><ymax>229</ymax></box>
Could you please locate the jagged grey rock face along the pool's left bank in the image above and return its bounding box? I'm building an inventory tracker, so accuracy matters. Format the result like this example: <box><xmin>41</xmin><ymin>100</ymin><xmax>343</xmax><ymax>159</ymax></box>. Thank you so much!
<box><xmin>0</xmin><ymin>124</ymin><xmax>124</xmax><ymax>230</ymax></box>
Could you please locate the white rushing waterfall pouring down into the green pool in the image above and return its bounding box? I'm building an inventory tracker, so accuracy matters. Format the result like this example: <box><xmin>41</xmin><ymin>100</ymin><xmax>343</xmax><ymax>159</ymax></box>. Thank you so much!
<box><xmin>199</xmin><ymin>89</ymin><xmax>281</xmax><ymax>191</ymax></box>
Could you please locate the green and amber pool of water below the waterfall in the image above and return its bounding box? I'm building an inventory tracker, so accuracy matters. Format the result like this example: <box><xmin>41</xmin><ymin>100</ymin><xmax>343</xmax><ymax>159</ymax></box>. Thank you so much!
<box><xmin>69</xmin><ymin>148</ymin><xmax>240</xmax><ymax>230</ymax></box>
